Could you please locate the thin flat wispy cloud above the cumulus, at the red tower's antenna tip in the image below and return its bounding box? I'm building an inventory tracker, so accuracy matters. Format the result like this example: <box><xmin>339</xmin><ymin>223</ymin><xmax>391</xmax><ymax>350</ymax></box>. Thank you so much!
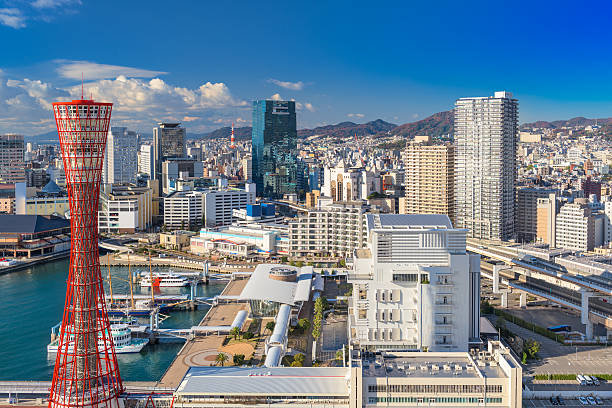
<box><xmin>55</xmin><ymin>60</ymin><xmax>166</xmax><ymax>81</ymax></box>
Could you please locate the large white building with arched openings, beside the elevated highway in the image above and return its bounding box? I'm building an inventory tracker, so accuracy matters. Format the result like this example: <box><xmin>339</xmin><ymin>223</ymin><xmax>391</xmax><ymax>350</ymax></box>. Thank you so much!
<box><xmin>348</xmin><ymin>214</ymin><xmax>480</xmax><ymax>351</ymax></box>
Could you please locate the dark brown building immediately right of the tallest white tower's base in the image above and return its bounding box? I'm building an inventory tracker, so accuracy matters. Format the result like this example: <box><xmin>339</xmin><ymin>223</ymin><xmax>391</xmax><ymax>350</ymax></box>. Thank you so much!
<box><xmin>516</xmin><ymin>187</ymin><xmax>556</xmax><ymax>242</ymax></box>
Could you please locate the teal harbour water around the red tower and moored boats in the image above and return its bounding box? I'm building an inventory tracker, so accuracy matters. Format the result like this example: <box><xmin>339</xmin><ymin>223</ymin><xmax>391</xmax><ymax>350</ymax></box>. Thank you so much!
<box><xmin>0</xmin><ymin>259</ymin><xmax>225</xmax><ymax>381</ymax></box>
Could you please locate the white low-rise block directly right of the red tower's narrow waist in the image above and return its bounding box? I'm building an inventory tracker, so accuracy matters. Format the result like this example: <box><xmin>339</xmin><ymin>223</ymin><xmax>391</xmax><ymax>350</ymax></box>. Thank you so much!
<box><xmin>98</xmin><ymin>184</ymin><xmax>154</xmax><ymax>234</ymax></box>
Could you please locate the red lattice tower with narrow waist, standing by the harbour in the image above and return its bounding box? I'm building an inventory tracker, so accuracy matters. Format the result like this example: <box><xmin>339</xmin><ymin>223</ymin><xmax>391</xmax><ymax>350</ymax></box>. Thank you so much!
<box><xmin>49</xmin><ymin>100</ymin><xmax>123</xmax><ymax>408</ymax></box>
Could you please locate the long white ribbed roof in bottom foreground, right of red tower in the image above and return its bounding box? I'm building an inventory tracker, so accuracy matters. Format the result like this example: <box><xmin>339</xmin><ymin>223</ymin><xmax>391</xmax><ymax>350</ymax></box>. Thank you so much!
<box><xmin>176</xmin><ymin>367</ymin><xmax>349</xmax><ymax>397</ymax></box>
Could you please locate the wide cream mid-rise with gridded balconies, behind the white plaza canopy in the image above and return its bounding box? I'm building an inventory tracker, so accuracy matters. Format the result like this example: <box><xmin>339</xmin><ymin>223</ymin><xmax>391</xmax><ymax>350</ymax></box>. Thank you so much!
<box><xmin>289</xmin><ymin>202</ymin><xmax>368</xmax><ymax>257</ymax></box>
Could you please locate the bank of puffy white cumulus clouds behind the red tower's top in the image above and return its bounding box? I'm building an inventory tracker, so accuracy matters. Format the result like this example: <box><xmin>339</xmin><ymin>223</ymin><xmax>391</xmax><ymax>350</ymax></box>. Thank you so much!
<box><xmin>0</xmin><ymin>71</ymin><xmax>249</xmax><ymax>135</ymax></box>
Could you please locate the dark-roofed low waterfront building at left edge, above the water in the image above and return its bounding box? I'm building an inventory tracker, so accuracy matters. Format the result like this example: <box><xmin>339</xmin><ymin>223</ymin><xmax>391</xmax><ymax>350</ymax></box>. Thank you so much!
<box><xmin>0</xmin><ymin>214</ymin><xmax>70</xmax><ymax>258</ymax></box>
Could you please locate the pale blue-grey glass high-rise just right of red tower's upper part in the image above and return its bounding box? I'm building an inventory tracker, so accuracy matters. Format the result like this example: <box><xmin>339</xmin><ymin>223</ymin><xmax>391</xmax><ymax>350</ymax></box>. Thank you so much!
<box><xmin>103</xmin><ymin>127</ymin><xmax>138</xmax><ymax>184</ymax></box>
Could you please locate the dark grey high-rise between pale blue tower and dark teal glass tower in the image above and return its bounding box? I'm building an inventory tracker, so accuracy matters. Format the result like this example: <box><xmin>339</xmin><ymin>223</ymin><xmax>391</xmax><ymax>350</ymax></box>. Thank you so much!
<box><xmin>151</xmin><ymin>123</ymin><xmax>186</xmax><ymax>180</ymax></box>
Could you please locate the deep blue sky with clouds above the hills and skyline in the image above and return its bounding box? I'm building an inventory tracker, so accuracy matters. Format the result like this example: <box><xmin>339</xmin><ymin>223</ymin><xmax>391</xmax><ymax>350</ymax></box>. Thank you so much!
<box><xmin>0</xmin><ymin>0</ymin><xmax>612</xmax><ymax>135</ymax></box>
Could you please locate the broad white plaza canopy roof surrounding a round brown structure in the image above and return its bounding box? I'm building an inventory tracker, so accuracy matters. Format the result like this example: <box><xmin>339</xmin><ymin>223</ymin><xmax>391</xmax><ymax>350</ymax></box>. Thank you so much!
<box><xmin>240</xmin><ymin>264</ymin><xmax>313</xmax><ymax>305</ymax></box>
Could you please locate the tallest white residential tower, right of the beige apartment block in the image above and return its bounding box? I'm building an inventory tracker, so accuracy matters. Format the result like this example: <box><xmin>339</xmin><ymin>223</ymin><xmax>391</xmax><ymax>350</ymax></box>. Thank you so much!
<box><xmin>455</xmin><ymin>92</ymin><xmax>518</xmax><ymax>240</ymax></box>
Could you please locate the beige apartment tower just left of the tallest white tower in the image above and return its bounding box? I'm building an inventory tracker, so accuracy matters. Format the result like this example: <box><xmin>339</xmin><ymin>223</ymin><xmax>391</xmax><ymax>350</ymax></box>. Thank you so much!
<box><xmin>400</xmin><ymin>136</ymin><xmax>455</xmax><ymax>222</ymax></box>
